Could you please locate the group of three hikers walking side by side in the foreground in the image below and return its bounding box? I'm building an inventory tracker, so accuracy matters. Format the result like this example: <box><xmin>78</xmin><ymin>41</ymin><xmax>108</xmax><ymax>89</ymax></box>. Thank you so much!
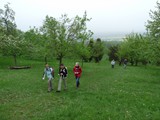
<box><xmin>42</xmin><ymin>62</ymin><xmax>82</xmax><ymax>92</ymax></box>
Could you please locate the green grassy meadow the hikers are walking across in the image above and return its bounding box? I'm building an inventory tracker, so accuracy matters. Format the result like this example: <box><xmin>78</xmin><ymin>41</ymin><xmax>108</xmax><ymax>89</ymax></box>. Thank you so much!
<box><xmin>0</xmin><ymin>58</ymin><xmax>160</xmax><ymax>120</ymax></box>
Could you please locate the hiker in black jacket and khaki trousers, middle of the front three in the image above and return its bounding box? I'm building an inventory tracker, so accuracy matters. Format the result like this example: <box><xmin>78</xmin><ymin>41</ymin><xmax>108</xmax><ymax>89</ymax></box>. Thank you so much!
<box><xmin>56</xmin><ymin>64</ymin><xmax>68</xmax><ymax>92</ymax></box>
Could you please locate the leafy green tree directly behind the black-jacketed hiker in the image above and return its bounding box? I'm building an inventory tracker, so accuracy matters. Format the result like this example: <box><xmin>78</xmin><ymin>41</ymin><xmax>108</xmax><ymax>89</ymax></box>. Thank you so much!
<box><xmin>41</xmin><ymin>15</ymin><xmax>70</xmax><ymax>64</ymax></box>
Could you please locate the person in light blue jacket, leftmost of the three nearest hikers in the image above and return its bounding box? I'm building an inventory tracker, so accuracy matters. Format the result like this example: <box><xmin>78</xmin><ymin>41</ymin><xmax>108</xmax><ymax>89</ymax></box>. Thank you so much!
<box><xmin>42</xmin><ymin>64</ymin><xmax>54</xmax><ymax>92</ymax></box>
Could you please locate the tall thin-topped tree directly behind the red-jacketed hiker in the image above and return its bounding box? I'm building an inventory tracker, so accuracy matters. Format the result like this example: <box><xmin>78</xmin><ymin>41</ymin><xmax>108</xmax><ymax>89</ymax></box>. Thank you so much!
<box><xmin>69</xmin><ymin>12</ymin><xmax>93</xmax><ymax>66</ymax></box>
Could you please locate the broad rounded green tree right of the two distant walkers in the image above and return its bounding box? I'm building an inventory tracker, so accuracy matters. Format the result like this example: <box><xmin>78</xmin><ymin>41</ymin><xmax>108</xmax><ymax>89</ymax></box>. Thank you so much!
<box><xmin>118</xmin><ymin>33</ymin><xmax>150</xmax><ymax>65</ymax></box>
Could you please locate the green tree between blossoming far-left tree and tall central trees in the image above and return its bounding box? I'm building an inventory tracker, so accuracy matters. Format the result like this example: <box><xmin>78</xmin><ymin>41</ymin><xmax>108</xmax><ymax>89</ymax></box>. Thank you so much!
<box><xmin>24</xmin><ymin>27</ymin><xmax>50</xmax><ymax>63</ymax></box>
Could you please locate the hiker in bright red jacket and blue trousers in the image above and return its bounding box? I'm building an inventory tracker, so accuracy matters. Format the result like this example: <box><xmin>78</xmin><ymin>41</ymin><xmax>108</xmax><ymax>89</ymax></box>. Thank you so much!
<box><xmin>73</xmin><ymin>62</ymin><xmax>82</xmax><ymax>88</ymax></box>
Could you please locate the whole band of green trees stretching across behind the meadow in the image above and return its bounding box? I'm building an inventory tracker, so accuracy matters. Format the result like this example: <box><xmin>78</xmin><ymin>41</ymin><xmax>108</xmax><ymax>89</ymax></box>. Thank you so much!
<box><xmin>0</xmin><ymin>2</ymin><xmax>160</xmax><ymax>65</ymax></box>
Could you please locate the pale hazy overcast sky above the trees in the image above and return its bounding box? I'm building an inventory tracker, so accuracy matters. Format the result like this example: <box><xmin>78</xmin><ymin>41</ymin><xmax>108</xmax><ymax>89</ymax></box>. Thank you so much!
<box><xmin>0</xmin><ymin>0</ymin><xmax>158</xmax><ymax>33</ymax></box>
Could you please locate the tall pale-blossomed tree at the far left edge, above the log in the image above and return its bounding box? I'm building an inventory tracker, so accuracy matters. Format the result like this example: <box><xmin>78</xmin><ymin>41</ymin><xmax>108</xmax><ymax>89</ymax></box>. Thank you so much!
<box><xmin>0</xmin><ymin>3</ymin><xmax>26</xmax><ymax>65</ymax></box>
